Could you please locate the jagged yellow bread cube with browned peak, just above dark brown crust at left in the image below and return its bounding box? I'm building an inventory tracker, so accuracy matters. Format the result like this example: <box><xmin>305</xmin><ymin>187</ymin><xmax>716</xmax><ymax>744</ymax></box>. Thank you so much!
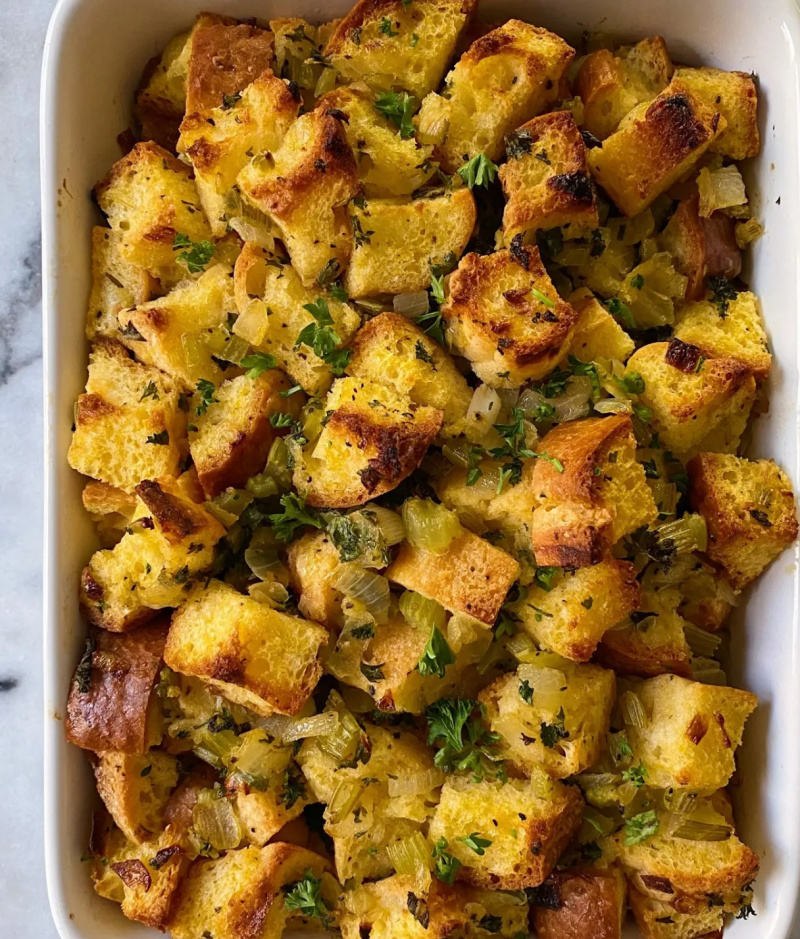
<box><xmin>80</xmin><ymin>480</ymin><xmax>225</xmax><ymax>632</ymax></box>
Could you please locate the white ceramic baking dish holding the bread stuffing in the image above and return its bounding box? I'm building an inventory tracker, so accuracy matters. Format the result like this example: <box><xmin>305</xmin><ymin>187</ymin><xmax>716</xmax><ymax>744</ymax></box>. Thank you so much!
<box><xmin>41</xmin><ymin>0</ymin><xmax>800</xmax><ymax>939</ymax></box>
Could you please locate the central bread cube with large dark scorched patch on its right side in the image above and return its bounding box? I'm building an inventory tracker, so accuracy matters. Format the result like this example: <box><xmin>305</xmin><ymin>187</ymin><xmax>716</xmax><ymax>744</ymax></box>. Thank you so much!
<box><xmin>294</xmin><ymin>378</ymin><xmax>442</xmax><ymax>508</ymax></box>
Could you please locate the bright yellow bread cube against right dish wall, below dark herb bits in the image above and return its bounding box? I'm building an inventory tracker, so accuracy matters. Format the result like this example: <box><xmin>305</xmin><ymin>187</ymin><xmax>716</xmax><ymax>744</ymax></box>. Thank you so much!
<box><xmin>674</xmin><ymin>291</ymin><xmax>772</xmax><ymax>381</ymax></box>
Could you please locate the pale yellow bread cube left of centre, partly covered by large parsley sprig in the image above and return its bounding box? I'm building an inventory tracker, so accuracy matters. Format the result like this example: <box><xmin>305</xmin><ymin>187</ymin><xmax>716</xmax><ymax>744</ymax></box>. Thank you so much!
<box><xmin>235</xmin><ymin>244</ymin><xmax>361</xmax><ymax>395</ymax></box>
